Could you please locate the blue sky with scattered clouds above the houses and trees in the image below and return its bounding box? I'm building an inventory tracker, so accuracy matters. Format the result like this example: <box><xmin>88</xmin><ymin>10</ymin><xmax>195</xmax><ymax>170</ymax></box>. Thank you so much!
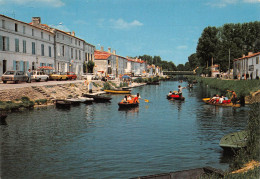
<box><xmin>0</xmin><ymin>0</ymin><xmax>260</xmax><ymax>65</ymax></box>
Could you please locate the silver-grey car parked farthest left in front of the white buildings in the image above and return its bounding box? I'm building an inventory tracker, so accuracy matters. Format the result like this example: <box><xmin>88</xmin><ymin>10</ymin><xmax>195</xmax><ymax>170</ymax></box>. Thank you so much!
<box><xmin>2</xmin><ymin>71</ymin><xmax>28</xmax><ymax>83</ymax></box>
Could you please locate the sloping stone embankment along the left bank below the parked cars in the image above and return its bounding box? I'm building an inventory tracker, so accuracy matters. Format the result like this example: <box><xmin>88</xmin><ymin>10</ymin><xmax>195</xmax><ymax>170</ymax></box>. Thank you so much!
<box><xmin>0</xmin><ymin>81</ymin><xmax>103</xmax><ymax>102</ymax></box>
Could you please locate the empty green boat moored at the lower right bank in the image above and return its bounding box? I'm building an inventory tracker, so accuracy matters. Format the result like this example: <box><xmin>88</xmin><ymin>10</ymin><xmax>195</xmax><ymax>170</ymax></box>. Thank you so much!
<box><xmin>219</xmin><ymin>130</ymin><xmax>247</xmax><ymax>150</ymax></box>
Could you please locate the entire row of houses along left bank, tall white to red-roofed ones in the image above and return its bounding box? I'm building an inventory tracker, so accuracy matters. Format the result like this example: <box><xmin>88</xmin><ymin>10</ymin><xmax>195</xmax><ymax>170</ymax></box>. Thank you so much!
<box><xmin>0</xmin><ymin>14</ymin><xmax>160</xmax><ymax>77</ymax></box>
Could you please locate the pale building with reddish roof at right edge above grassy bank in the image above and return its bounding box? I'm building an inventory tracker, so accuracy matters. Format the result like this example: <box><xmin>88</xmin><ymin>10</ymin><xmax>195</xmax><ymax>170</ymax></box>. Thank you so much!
<box><xmin>233</xmin><ymin>52</ymin><xmax>260</xmax><ymax>79</ymax></box>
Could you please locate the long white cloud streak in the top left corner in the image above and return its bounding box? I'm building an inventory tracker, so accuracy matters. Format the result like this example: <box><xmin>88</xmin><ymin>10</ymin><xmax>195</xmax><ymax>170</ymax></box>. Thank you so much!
<box><xmin>0</xmin><ymin>0</ymin><xmax>65</xmax><ymax>7</ymax></box>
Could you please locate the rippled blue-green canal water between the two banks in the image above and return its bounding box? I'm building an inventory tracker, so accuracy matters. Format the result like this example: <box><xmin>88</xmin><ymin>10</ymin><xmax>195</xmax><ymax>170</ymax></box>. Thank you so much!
<box><xmin>0</xmin><ymin>81</ymin><xmax>249</xmax><ymax>178</ymax></box>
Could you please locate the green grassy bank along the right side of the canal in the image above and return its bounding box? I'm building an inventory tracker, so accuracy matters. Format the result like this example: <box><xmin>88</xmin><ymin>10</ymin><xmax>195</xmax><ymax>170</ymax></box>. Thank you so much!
<box><xmin>188</xmin><ymin>76</ymin><xmax>260</xmax><ymax>98</ymax></box>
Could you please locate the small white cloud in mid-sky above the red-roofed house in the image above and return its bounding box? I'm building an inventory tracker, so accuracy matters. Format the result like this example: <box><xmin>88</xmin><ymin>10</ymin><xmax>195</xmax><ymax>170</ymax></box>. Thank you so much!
<box><xmin>109</xmin><ymin>18</ymin><xmax>143</xmax><ymax>29</ymax></box>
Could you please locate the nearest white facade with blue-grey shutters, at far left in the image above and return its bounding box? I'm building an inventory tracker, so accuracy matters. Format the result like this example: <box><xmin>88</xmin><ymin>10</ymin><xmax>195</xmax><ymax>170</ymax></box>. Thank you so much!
<box><xmin>0</xmin><ymin>15</ymin><xmax>54</xmax><ymax>75</ymax></box>
